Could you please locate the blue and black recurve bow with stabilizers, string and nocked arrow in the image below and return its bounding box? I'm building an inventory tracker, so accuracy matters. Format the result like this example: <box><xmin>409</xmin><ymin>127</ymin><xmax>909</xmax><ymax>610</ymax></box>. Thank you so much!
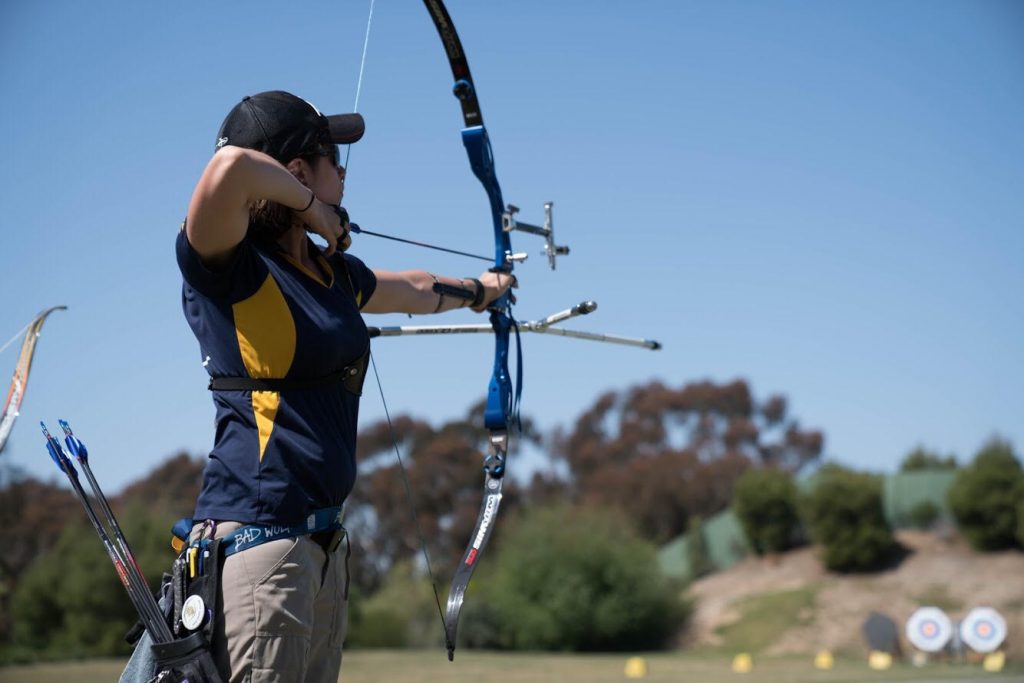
<box><xmin>346</xmin><ymin>0</ymin><xmax>662</xmax><ymax>660</ymax></box>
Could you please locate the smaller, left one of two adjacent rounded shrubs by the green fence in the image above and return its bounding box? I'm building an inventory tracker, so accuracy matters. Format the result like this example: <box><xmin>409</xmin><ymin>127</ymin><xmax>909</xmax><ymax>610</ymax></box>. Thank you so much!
<box><xmin>732</xmin><ymin>469</ymin><xmax>800</xmax><ymax>555</ymax></box>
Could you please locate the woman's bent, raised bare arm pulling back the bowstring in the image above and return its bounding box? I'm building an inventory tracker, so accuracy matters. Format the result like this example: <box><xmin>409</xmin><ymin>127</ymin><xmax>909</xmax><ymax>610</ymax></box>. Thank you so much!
<box><xmin>185</xmin><ymin>145</ymin><xmax>312</xmax><ymax>266</ymax></box>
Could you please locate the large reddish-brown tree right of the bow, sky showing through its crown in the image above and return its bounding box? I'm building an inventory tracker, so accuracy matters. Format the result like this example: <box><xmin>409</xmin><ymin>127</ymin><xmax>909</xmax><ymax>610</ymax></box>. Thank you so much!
<box><xmin>552</xmin><ymin>380</ymin><xmax>824</xmax><ymax>543</ymax></box>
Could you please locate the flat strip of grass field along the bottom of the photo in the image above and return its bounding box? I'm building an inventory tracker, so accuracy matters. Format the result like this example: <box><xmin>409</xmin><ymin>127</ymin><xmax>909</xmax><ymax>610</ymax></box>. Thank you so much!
<box><xmin>0</xmin><ymin>650</ymin><xmax>1024</xmax><ymax>683</ymax></box>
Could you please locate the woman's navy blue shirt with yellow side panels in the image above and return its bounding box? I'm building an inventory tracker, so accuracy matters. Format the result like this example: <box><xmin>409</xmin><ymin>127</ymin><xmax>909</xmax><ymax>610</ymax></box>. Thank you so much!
<box><xmin>176</xmin><ymin>227</ymin><xmax>377</xmax><ymax>524</ymax></box>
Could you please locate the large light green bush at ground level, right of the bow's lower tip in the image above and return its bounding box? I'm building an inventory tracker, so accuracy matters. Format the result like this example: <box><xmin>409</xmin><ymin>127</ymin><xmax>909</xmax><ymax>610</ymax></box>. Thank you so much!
<box><xmin>477</xmin><ymin>507</ymin><xmax>688</xmax><ymax>651</ymax></box>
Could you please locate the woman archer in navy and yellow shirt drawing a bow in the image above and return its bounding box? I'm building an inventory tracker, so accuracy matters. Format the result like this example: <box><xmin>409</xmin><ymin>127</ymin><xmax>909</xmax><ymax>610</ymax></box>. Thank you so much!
<box><xmin>176</xmin><ymin>91</ymin><xmax>514</xmax><ymax>683</ymax></box>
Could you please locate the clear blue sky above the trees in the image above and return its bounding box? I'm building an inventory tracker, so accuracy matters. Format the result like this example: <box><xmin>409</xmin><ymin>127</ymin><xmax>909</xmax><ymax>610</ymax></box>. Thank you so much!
<box><xmin>0</xmin><ymin>0</ymin><xmax>1024</xmax><ymax>490</ymax></box>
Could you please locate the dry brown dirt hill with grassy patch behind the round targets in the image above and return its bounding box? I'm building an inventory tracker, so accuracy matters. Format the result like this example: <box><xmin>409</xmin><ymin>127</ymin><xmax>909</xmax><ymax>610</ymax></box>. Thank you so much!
<box><xmin>686</xmin><ymin>531</ymin><xmax>1024</xmax><ymax>659</ymax></box>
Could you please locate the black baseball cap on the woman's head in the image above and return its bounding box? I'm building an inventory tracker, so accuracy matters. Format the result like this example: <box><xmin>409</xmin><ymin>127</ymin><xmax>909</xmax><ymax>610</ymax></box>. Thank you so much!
<box><xmin>217</xmin><ymin>90</ymin><xmax>366</xmax><ymax>164</ymax></box>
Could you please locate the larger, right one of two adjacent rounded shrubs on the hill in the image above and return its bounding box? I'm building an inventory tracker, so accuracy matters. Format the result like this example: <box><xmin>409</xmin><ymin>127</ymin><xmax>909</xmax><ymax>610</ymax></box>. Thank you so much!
<box><xmin>802</xmin><ymin>467</ymin><xmax>899</xmax><ymax>571</ymax></box>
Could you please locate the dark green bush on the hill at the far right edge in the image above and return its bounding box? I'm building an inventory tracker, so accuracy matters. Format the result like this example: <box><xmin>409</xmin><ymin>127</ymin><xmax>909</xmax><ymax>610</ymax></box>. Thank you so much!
<box><xmin>948</xmin><ymin>438</ymin><xmax>1024</xmax><ymax>550</ymax></box>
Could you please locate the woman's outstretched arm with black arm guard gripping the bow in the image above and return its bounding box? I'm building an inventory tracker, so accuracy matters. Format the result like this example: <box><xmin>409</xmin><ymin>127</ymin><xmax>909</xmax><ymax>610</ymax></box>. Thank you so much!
<box><xmin>362</xmin><ymin>270</ymin><xmax>516</xmax><ymax>313</ymax></box>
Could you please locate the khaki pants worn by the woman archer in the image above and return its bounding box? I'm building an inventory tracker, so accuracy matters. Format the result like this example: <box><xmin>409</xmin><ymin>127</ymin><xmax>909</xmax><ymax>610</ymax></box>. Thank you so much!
<box><xmin>194</xmin><ymin>522</ymin><xmax>349</xmax><ymax>683</ymax></box>
